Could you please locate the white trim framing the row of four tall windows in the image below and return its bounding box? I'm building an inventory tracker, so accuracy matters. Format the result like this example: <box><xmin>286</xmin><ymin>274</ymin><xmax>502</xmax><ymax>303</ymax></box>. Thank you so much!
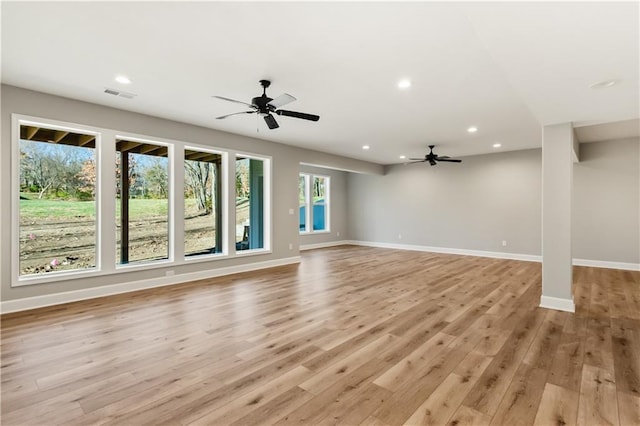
<box><xmin>10</xmin><ymin>113</ymin><xmax>273</xmax><ymax>287</ymax></box>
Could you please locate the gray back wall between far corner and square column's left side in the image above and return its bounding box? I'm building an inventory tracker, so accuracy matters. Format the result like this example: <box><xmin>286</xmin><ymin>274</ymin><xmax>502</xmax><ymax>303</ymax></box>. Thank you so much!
<box><xmin>348</xmin><ymin>149</ymin><xmax>542</xmax><ymax>255</ymax></box>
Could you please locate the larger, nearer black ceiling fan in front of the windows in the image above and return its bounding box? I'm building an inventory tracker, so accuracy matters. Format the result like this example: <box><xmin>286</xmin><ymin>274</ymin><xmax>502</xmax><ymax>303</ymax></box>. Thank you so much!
<box><xmin>214</xmin><ymin>80</ymin><xmax>320</xmax><ymax>129</ymax></box>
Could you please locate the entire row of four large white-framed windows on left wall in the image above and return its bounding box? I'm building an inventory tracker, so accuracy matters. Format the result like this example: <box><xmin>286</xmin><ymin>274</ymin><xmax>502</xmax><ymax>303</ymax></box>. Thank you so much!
<box><xmin>10</xmin><ymin>114</ymin><xmax>271</xmax><ymax>286</ymax></box>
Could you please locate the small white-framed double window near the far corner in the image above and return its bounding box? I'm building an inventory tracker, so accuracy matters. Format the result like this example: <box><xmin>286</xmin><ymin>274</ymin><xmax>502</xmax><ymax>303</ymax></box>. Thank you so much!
<box><xmin>298</xmin><ymin>173</ymin><xmax>330</xmax><ymax>233</ymax></box>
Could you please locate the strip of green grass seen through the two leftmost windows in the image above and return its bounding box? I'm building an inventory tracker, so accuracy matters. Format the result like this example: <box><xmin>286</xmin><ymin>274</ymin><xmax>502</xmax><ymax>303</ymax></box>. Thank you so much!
<box><xmin>20</xmin><ymin>199</ymin><xmax>168</xmax><ymax>220</ymax></box>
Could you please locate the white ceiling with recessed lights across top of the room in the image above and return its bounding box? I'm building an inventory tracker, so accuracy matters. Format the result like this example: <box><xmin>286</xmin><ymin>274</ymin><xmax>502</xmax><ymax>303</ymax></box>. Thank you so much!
<box><xmin>1</xmin><ymin>2</ymin><xmax>640</xmax><ymax>164</ymax></box>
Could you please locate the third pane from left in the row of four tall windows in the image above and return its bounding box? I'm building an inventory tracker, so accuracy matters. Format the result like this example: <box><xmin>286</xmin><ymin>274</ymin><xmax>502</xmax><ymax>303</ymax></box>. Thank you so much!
<box><xmin>184</xmin><ymin>149</ymin><xmax>223</xmax><ymax>256</ymax></box>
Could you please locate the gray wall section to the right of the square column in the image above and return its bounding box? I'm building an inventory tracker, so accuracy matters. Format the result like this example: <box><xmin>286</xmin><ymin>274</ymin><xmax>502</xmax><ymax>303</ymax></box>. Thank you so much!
<box><xmin>573</xmin><ymin>138</ymin><xmax>640</xmax><ymax>264</ymax></box>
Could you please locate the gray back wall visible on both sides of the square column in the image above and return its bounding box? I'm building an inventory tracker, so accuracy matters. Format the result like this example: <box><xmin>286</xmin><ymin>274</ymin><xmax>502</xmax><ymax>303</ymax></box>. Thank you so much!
<box><xmin>348</xmin><ymin>138</ymin><xmax>640</xmax><ymax>264</ymax></box>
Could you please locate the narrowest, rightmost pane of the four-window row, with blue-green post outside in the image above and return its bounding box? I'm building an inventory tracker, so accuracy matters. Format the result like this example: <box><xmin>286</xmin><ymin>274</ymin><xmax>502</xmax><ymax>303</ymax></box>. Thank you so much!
<box><xmin>236</xmin><ymin>157</ymin><xmax>264</xmax><ymax>250</ymax></box>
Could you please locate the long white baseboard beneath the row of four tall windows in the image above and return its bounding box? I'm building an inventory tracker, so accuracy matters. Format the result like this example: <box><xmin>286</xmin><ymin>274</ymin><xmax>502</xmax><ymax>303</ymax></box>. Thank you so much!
<box><xmin>0</xmin><ymin>256</ymin><xmax>300</xmax><ymax>314</ymax></box>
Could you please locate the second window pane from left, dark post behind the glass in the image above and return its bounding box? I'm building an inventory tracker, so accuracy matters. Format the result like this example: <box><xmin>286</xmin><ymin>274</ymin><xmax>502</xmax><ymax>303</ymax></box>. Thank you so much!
<box><xmin>116</xmin><ymin>140</ymin><xmax>169</xmax><ymax>264</ymax></box>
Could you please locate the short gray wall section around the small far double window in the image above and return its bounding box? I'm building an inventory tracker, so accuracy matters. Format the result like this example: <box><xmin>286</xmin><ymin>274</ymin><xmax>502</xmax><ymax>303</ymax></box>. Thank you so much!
<box><xmin>296</xmin><ymin>164</ymin><xmax>349</xmax><ymax>247</ymax></box>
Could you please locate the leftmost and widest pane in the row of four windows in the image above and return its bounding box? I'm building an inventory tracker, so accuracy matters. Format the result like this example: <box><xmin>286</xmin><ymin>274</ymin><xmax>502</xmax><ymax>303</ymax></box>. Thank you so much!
<box><xmin>19</xmin><ymin>125</ymin><xmax>97</xmax><ymax>276</ymax></box>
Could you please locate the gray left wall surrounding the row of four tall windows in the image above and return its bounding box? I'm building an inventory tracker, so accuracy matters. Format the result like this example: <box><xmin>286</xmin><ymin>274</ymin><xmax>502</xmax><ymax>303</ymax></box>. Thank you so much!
<box><xmin>0</xmin><ymin>85</ymin><xmax>383</xmax><ymax>301</ymax></box>
